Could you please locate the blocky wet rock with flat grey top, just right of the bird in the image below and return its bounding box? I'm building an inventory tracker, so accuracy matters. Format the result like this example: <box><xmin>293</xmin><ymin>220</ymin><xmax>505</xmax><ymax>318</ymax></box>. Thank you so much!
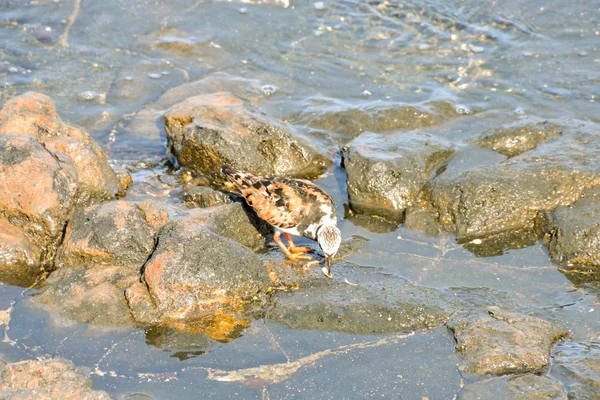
<box><xmin>344</xmin><ymin>133</ymin><xmax>454</xmax><ymax>219</ymax></box>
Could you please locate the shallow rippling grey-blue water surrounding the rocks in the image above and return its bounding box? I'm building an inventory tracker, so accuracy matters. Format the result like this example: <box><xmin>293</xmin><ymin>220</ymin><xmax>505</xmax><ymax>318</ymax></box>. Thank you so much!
<box><xmin>0</xmin><ymin>0</ymin><xmax>600</xmax><ymax>399</ymax></box>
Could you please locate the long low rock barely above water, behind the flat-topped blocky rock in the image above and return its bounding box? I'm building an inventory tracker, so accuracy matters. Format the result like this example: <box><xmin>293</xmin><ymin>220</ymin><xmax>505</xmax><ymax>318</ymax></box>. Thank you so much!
<box><xmin>290</xmin><ymin>98</ymin><xmax>457</xmax><ymax>143</ymax></box>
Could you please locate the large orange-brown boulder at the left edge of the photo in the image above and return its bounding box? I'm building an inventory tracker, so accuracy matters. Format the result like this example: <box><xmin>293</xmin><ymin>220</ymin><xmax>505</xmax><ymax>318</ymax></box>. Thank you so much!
<box><xmin>0</xmin><ymin>93</ymin><xmax>123</xmax><ymax>284</ymax></box>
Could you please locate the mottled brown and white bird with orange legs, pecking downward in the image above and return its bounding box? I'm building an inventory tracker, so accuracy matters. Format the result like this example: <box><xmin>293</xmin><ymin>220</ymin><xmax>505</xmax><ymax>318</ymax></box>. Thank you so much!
<box><xmin>221</xmin><ymin>165</ymin><xmax>341</xmax><ymax>278</ymax></box>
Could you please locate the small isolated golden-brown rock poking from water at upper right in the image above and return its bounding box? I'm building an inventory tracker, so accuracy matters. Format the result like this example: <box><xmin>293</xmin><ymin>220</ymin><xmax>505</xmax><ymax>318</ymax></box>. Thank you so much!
<box><xmin>475</xmin><ymin>118</ymin><xmax>564</xmax><ymax>157</ymax></box>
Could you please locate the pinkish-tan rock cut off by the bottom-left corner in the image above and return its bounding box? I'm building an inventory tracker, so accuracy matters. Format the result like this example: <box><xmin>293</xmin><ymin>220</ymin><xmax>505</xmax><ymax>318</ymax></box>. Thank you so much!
<box><xmin>0</xmin><ymin>358</ymin><xmax>111</xmax><ymax>400</ymax></box>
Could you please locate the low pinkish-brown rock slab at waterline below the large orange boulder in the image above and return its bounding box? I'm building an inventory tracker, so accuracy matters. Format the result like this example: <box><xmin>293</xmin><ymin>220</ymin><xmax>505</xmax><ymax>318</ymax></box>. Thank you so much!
<box><xmin>32</xmin><ymin>266</ymin><xmax>140</xmax><ymax>326</ymax></box>
